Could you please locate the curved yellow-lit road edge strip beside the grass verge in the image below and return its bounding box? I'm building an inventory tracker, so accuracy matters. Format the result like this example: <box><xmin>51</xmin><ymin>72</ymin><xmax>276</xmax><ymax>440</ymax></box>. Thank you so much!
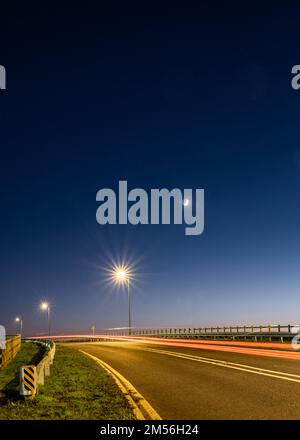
<box><xmin>80</xmin><ymin>350</ymin><xmax>162</xmax><ymax>420</ymax></box>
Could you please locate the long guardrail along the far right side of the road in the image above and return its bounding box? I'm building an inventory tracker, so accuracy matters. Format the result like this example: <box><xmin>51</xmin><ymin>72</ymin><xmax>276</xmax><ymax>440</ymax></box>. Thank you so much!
<box><xmin>107</xmin><ymin>324</ymin><xmax>300</xmax><ymax>342</ymax></box>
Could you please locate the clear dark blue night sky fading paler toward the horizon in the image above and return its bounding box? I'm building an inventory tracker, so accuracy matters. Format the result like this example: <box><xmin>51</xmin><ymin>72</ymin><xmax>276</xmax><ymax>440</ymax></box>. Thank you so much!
<box><xmin>0</xmin><ymin>2</ymin><xmax>300</xmax><ymax>333</ymax></box>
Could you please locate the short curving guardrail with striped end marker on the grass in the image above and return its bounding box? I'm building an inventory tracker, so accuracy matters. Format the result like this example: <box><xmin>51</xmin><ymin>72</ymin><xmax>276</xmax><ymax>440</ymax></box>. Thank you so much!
<box><xmin>20</xmin><ymin>339</ymin><xmax>56</xmax><ymax>398</ymax></box>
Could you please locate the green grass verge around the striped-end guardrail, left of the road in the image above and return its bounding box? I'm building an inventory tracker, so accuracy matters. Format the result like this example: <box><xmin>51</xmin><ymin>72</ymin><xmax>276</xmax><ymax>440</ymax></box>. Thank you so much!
<box><xmin>0</xmin><ymin>343</ymin><xmax>134</xmax><ymax>420</ymax></box>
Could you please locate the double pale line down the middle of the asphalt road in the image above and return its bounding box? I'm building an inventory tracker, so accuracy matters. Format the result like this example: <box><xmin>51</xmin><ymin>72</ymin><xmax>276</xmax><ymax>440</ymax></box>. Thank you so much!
<box><xmin>140</xmin><ymin>348</ymin><xmax>300</xmax><ymax>383</ymax></box>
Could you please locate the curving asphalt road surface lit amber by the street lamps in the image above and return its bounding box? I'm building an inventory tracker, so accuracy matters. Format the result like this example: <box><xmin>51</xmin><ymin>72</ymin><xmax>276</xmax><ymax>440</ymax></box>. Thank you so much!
<box><xmin>71</xmin><ymin>341</ymin><xmax>300</xmax><ymax>419</ymax></box>
